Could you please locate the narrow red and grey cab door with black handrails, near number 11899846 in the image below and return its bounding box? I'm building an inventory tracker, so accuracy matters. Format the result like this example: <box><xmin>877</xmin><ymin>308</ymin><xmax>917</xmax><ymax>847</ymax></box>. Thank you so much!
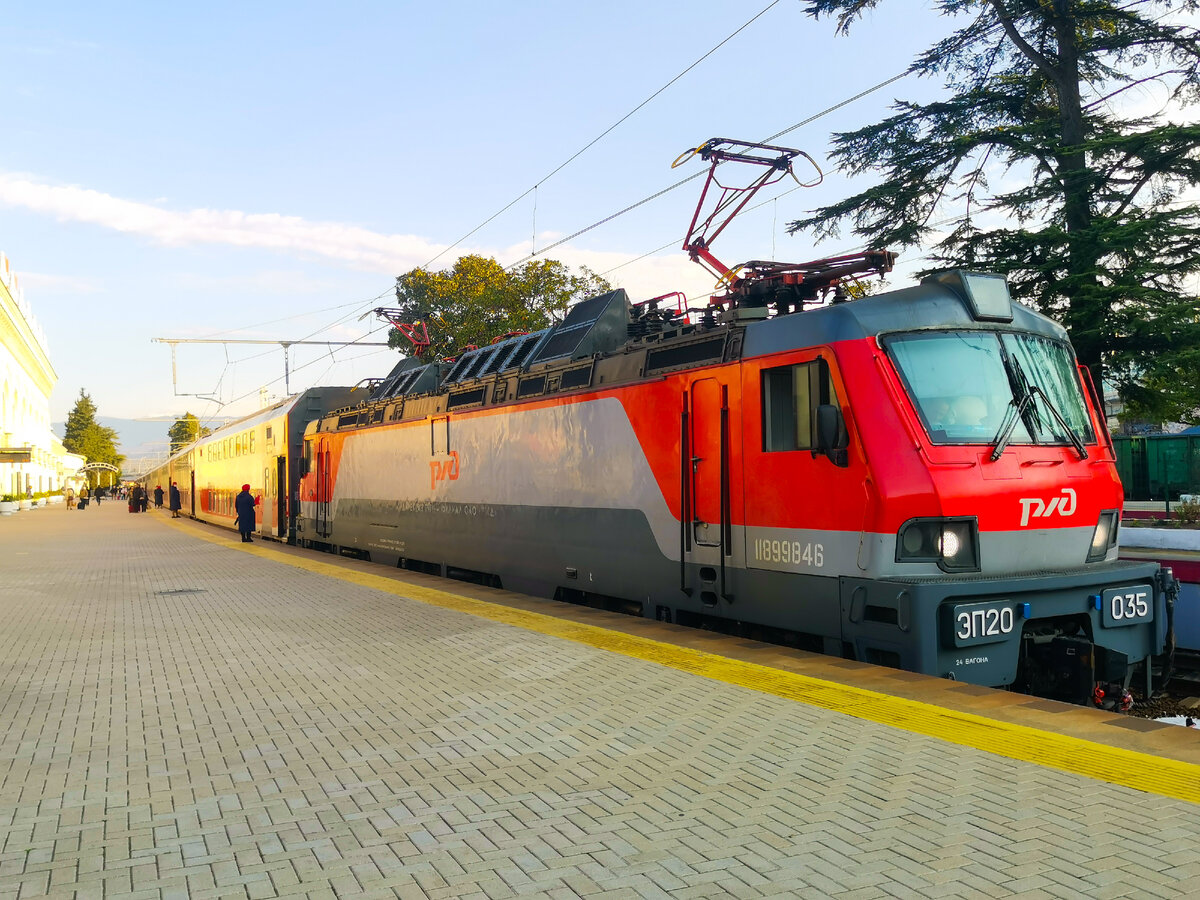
<box><xmin>680</xmin><ymin>378</ymin><xmax>733</xmax><ymax>606</ymax></box>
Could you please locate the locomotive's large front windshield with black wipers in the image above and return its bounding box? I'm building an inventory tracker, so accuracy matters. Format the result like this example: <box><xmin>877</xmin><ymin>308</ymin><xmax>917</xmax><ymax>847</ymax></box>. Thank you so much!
<box><xmin>883</xmin><ymin>331</ymin><xmax>1094</xmax><ymax>445</ymax></box>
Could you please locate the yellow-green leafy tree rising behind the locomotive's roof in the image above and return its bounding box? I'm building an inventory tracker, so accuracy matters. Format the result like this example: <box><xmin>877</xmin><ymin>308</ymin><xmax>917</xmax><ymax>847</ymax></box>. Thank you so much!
<box><xmin>388</xmin><ymin>256</ymin><xmax>612</xmax><ymax>359</ymax></box>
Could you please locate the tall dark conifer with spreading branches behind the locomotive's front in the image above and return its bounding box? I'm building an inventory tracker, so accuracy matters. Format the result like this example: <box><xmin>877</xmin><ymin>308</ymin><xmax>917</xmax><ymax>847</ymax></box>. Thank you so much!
<box><xmin>788</xmin><ymin>0</ymin><xmax>1200</xmax><ymax>421</ymax></box>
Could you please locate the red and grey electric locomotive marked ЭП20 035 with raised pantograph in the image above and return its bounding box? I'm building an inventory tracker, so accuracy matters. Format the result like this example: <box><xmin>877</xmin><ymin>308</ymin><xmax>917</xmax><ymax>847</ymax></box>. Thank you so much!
<box><xmin>296</xmin><ymin>139</ymin><xmax>1170</xmax><ymax>702</ymax></box>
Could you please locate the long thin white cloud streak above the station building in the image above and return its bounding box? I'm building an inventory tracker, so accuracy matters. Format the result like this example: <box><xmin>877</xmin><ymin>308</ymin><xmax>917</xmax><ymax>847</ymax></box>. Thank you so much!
<box><xmin>0</xmin><ymin>173</ymin><xmax>444</xmax><ymax>274</ymax></box>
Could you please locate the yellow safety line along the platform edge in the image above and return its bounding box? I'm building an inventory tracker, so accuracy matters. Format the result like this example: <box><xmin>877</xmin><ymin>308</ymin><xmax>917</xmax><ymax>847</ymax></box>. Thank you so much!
<box><xmin>177</xmin><ymin>530</ymin><xmax>1200</xmax><ymax>803</ymax></box>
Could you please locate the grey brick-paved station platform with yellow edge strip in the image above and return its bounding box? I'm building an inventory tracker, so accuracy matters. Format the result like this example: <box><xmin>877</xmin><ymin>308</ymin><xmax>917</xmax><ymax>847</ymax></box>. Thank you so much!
<box><xmin>0</xmin><ymin>503</ymin><xmax>1200</xmax><ymax>900</ymax></box>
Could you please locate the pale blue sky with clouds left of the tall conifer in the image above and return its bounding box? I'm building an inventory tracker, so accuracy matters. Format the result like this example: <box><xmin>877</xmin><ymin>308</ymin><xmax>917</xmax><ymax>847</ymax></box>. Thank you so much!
<box><xmin>0</xmin><ymin>0</ymin><xmax>950</xmax><ymax>439</ymax></box>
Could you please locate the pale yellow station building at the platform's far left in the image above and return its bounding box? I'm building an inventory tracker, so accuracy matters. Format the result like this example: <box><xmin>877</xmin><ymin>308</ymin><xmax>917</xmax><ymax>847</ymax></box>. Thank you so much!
<box><xmin>0</xmin><ymin>253</ymin><xmax>85</xmax><ymax>496</ymax></box>
